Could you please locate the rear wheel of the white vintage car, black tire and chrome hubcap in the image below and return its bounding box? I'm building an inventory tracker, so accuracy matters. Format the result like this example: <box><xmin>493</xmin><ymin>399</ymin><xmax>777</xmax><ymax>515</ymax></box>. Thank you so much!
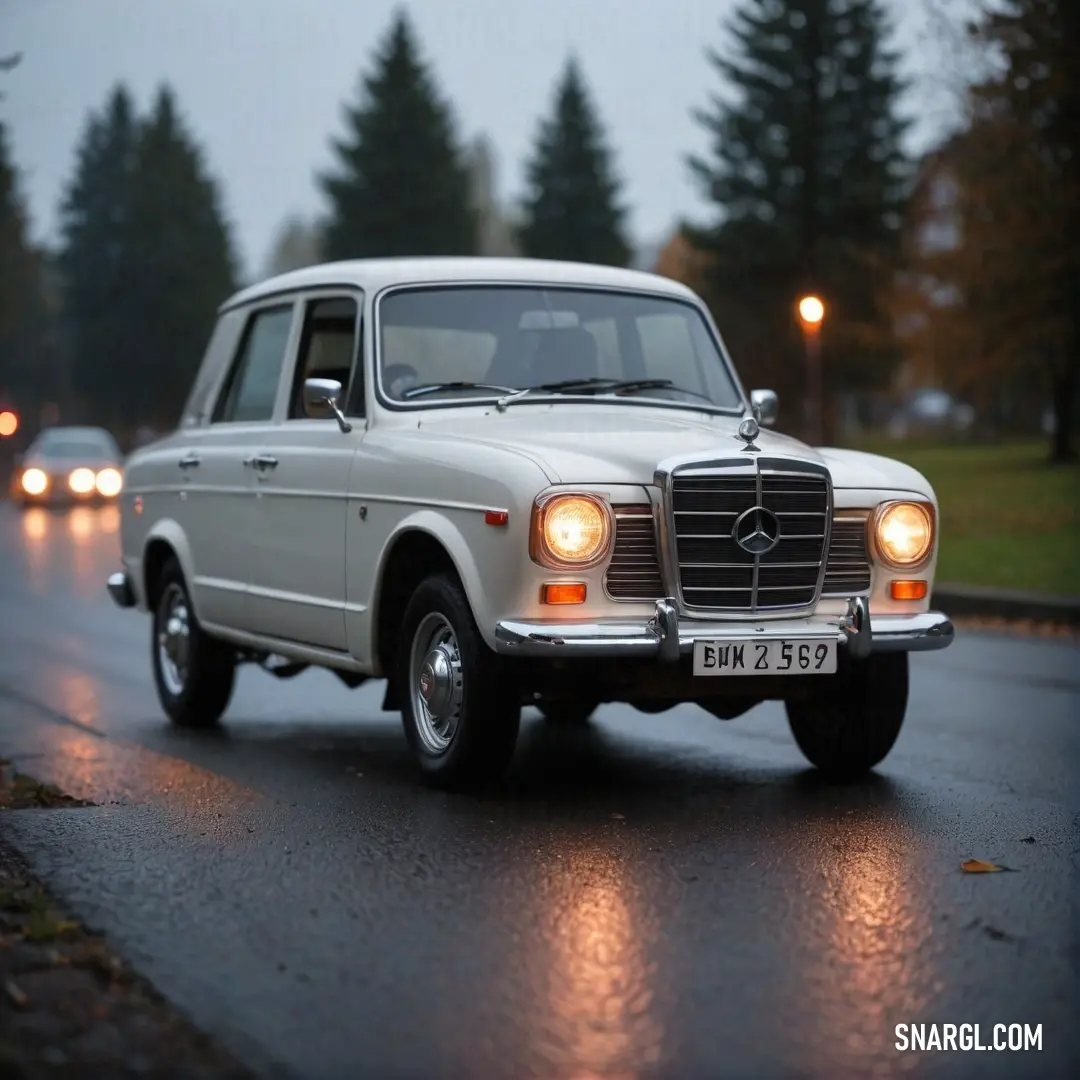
<box><xmin>150</xmin><ymin>558</ymin><xmax>237</xmax><ymax>729</ymax></box>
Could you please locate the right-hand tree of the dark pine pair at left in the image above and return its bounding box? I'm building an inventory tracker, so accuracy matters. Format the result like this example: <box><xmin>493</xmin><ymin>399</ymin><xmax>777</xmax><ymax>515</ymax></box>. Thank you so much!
<box><xmin>124</xmin><ymin>86</ymin><xmax>237</xmax><ymax>423</ymax></box>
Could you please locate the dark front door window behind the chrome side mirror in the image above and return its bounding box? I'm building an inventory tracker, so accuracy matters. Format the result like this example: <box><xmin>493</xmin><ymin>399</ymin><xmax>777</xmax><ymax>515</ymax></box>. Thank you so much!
<box><xmin>288</xmin><ymin>296</ymin><xmax>364</xmax><ymax>420</ymax></box>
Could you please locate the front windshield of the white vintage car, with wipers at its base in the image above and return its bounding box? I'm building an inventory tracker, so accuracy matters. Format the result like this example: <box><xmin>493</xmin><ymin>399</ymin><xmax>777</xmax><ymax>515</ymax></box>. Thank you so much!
<box><xmin>379</xmin><ymin>285</ymin><xmax>742</xmax><ymax>409</ymax></box>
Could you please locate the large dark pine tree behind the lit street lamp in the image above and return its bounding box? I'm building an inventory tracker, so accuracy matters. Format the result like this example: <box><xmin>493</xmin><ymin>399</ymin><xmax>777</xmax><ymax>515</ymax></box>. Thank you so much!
<box><xmin>690</xmin><ymin>0</ymin><xmax>908</xmax><ymax>434</ymax></box>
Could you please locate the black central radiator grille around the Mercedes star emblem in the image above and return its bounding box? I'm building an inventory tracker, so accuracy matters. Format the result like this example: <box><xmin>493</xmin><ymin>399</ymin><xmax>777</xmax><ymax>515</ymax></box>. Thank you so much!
<box><xmin>671</xmin><ymin>462</ymin><xmax>832</xmax><ymax>613</ymax></box>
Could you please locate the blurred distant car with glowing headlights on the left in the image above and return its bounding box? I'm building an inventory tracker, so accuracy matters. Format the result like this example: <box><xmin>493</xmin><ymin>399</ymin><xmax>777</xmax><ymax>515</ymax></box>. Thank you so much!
<box><xmin>11</xmin><ymin>427</ymin><xmax>124</xmax><ymax>505</ymax></box>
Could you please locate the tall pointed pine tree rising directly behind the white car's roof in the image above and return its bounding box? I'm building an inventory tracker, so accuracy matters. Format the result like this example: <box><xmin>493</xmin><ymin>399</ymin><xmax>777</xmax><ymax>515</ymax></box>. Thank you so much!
<box><xmin>320</xmin><ymin>12</ymin><xmax>476</xmax><ymax>259</ymax></box>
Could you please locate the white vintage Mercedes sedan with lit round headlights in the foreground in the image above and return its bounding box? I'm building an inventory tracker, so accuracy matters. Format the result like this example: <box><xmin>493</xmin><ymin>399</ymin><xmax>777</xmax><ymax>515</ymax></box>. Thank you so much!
<box><xmin>108</xmin><ymin>258</ymin><xmax>953</xmax><ymax>783</ymax></box>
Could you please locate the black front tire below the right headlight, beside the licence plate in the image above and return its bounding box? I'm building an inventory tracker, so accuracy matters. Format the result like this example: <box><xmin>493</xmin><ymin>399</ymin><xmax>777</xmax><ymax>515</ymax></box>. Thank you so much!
<box><xmin>785</xmin><ymin>652</ymin><xmax>908</xmax><ymax>780</ymax></box>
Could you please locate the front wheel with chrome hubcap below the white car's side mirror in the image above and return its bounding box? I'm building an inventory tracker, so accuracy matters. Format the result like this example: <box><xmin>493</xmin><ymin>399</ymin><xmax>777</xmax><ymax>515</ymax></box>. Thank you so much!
<box><xmin>397</xmin><ymin>573</ymin><xmax>522</xmax><ymax>787</ymax></box>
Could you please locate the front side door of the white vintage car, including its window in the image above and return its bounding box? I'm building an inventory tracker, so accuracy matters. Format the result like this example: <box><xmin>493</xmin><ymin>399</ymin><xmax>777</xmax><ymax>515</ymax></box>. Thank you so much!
<box><xmin>244</xmin><ymin>289</ymin><xmax>366</xmax><ymax>652</ymax></box>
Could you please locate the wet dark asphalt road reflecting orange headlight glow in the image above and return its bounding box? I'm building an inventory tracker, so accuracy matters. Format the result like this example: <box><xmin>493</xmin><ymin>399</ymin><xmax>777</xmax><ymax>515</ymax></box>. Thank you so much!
<box><xmin>0</xmin><ymin>503</ymin><xmax>1080</xmax><ymax>1080</ymax></box>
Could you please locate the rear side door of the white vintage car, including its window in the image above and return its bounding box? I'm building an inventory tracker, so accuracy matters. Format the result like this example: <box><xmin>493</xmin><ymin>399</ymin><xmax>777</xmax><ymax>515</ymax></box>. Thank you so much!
<box><xmin>176</xmin><ymin>299</ymin><xmax>296</xmax><ymax>631</ymax></box>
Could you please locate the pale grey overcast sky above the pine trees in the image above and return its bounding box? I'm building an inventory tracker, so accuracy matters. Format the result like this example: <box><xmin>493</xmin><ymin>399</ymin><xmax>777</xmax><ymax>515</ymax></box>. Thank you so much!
<box><xmin>0</xmin><ymin>0</ymin><xmax>963</xmax><ymax>274</ymax></box>
